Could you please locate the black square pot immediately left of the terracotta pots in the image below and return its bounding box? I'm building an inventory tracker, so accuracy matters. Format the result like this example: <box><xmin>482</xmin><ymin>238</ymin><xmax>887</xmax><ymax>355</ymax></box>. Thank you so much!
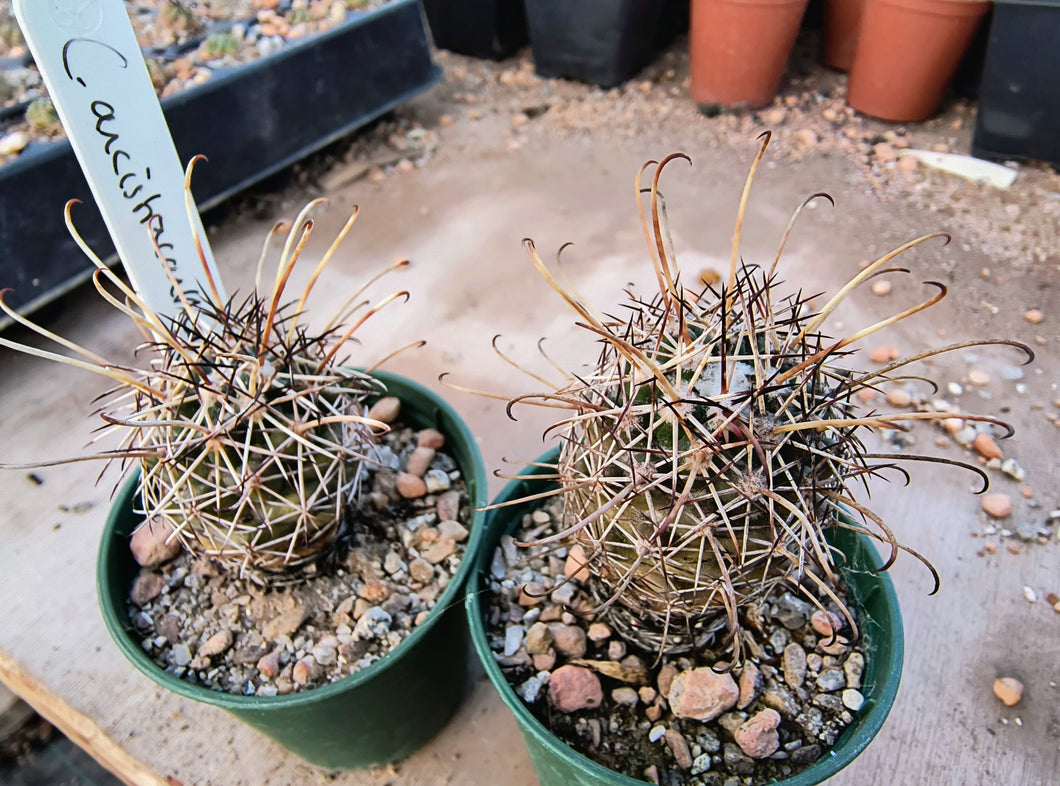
<box><xmin>526</xmin><ymin>0</ymin><xmax>666</xmax><ymax>87</ymax></box>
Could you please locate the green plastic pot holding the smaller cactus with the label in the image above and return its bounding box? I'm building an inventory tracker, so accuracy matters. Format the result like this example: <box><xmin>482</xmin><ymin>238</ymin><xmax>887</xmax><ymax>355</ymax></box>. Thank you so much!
<box><xmin>96</xmin><ymin>371</ymin><xmax>487</xmax><ymax>769</ymax></box>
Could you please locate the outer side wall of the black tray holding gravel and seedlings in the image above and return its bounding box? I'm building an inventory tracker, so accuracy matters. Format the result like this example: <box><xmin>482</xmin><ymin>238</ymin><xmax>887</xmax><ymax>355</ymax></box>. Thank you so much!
<box><xmin>0</xmin><ymin>0</ymin><xmax>441</xmax><ymax>325</ymax></box>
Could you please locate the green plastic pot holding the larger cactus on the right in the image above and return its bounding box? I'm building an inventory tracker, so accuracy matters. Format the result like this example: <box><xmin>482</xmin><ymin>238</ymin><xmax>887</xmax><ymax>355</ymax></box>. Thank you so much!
<box><xmin>465</xmin><ymin>449</ymin><xmax>903</xmax><ymax>786</ymax></box>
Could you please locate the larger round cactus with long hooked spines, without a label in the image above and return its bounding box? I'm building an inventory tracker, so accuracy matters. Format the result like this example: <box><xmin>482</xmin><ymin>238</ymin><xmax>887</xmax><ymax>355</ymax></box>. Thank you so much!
<box><xmin>487</xmin><ymin>135</ymin><xmax>1032</xmax><ymax>662</ymax></box>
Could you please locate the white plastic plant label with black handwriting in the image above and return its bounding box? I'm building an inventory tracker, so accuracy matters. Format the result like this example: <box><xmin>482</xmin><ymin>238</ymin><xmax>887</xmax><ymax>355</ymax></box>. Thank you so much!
<box><xmin>14</xmin><ymin>0</ymin><xmax>226</xmax><ymax>317</ymax></box>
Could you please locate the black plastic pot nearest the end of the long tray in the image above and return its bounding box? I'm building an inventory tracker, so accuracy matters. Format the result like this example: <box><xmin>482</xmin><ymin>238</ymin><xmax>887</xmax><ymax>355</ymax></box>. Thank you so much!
<box><xmin>422</xmin><ymin>0</ymin><xmax>527</xmax><ymax>60</ymax></box>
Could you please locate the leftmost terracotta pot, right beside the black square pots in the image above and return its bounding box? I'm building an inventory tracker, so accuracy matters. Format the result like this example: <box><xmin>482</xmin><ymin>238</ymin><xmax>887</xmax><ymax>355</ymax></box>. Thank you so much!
<box><xmin>688</xmin><ymin>0</ymin><xmax>808</xmax><ymax>107</ymax></box>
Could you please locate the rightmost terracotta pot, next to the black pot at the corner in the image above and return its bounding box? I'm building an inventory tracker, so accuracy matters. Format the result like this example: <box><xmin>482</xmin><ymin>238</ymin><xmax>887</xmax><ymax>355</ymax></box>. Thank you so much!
<box><xmin>847</xmin><ymin>0</ymin><xmax>990</xmax><ymax>123</ymax></box>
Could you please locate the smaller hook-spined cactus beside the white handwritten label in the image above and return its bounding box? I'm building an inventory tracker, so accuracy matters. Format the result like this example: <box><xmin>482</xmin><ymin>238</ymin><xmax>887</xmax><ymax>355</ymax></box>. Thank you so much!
<box><xmin>0</xmin><ymin>162</ymin><xmax>407</xmax><ymax>578</ymax></box>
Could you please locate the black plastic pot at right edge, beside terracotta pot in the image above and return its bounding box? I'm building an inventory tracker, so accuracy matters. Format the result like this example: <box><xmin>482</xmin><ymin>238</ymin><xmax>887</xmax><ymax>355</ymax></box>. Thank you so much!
<box><xmin>972</xmin><ymin>0</ymin><xmax>1060</xmax><ymax>166</ymax></box>
